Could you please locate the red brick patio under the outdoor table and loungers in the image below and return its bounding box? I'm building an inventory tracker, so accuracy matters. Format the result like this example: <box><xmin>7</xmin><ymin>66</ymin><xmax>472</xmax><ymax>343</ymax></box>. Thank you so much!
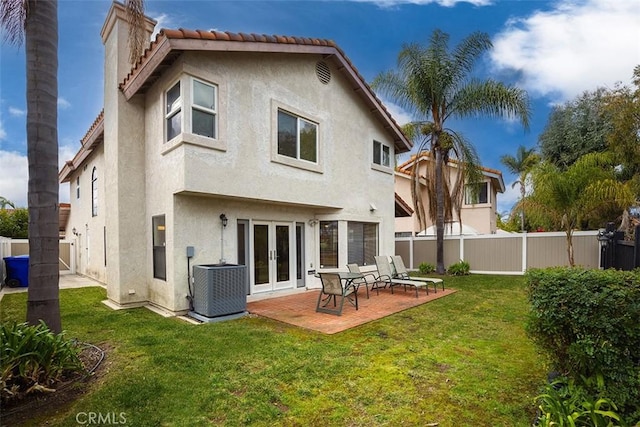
<box><xmin>247</xmin><ymin>287</ymin><xmax>455</xmax><ymax>334</ymax></box>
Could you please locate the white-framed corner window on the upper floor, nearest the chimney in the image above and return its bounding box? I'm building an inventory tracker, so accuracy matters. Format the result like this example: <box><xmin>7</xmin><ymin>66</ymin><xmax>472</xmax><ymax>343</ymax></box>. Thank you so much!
<box><xmin>165</xmin><ymin>77</ymin><xmax>218</xmax><ymax>141</ymax></box>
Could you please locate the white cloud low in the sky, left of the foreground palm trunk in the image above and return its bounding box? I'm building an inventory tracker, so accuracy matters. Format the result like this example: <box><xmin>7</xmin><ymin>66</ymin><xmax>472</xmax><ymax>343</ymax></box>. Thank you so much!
<box><xmin>0</xmin><ymin>151</ymin><xmax>29</xmax><ymax>207</ymax></box>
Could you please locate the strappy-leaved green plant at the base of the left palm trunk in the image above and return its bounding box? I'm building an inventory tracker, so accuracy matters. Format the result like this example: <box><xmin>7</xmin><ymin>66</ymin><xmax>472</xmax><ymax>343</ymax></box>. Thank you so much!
<box><xmin>0</xmin><ymin>322</ymin><xmax>84</xmax><ymax>401</ymax></box>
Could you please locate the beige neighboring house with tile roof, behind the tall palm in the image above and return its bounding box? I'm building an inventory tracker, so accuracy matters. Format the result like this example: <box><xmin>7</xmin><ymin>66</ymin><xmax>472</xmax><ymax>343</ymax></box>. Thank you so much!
<box><xmin>395</xmin><ymin>153</ymin><xmax>504</xmax><ymax>236</ymax></box>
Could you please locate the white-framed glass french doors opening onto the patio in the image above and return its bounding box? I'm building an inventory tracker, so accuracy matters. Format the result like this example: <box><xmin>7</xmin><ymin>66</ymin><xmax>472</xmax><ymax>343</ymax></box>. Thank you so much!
<box><xmin>251</xmin><ymin>221</ymin><xmax>296</xmax><ymax>292</ymax></box>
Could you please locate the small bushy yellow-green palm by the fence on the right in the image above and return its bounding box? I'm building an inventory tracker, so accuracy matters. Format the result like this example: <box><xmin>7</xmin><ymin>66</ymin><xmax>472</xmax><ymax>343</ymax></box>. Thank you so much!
<box><xmin>520</xmin><ymin>153</ymin><xmax>635</xmax><ymax>266</ymax></box>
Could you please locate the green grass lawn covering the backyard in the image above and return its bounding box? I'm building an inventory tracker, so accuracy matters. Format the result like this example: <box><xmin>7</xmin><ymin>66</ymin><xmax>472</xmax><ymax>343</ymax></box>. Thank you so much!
<box><xmin>0</xmin><ymin>276</ymin><xmax>546</xmax><ymax>427</ymax></box>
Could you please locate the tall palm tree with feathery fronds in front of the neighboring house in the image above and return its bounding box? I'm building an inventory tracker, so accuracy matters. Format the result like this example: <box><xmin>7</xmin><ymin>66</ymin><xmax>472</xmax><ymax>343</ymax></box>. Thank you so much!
<box><xmin>372</xmin><ymin>30</ymin><xmax>530</xmax><ymax>274</ymax></box>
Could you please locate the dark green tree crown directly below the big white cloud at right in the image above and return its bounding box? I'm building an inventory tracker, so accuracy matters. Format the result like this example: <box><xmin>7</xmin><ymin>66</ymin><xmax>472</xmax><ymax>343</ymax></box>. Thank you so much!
<box><xmin>538</xmin><ymin>88</ymin><xmax>612</xmax><ymax>170</ymax></box>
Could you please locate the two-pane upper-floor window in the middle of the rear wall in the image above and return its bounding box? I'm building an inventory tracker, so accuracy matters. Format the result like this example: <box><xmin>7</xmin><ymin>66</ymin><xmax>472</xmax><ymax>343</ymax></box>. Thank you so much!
<box><xmin>278</xmin><ymin>109</ymin><xmax>318</xmax><ymax>163</ymax></box>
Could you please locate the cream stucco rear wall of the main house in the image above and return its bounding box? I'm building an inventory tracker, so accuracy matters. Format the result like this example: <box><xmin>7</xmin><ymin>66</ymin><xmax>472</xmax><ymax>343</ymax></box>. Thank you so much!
<box><xmin>138</xmin><ymin>53</ymin><xmax>394</xmax><ymax>311</ymax></box>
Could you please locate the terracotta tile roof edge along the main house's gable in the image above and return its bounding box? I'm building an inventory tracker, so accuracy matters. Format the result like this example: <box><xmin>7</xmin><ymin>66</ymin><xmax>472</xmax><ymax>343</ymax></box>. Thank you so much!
<box><xmin>120</xmin><ymin>28</ymin><xmax>413</xmax><ymax>152</ymax></box>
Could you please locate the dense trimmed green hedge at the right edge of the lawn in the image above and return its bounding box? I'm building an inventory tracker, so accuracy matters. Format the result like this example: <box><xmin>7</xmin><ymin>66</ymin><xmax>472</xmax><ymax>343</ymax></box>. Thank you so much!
<box><xmin>526</xmin><ymin>267</ymin><xmax>640</xmax><ymax>423</ymax></box>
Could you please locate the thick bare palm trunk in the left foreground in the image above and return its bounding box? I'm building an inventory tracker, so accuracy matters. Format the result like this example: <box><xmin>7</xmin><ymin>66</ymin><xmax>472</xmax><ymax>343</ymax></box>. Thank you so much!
<box><xmin>25</xmin><ymin>0</ymin><xmax>62</xmax><ymax>332</ymax></box>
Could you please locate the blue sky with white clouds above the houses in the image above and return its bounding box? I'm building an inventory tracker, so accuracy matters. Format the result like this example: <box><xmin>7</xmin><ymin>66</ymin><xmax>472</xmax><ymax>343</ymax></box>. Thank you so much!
<box><xmin>0</xmin><ymin>0</ymin><xmax>640</xmax><ymax>216</ymax></box>
